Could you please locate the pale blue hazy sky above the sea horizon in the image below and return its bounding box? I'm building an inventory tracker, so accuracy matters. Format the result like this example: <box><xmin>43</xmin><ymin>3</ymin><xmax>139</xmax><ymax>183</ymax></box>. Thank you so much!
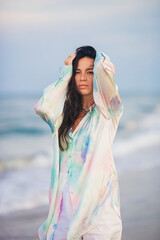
<box><xmin>0</xmin><ymin>0</ymin><xmax>160</xmax><ymax>96</ymax></box>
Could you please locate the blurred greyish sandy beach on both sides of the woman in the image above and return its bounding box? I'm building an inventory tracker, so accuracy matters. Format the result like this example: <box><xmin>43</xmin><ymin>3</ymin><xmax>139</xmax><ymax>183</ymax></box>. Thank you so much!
<box><xmin>0</xmin><ymin>167</ymin><xmax>160</xmax><ymax>240</ymax></box>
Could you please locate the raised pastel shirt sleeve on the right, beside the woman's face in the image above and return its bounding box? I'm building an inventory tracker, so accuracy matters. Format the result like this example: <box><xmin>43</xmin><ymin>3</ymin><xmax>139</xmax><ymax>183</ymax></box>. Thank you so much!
<box><xmin>93</xmin><ymin>52</ymin><xmax>123</xmax><ymax>120</ymax></box>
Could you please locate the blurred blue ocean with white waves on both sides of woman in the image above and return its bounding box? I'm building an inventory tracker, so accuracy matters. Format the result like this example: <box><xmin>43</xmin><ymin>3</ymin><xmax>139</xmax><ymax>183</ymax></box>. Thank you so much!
<box><xmin>0</xmin><ymin>95</ymin><xmax>160</xmax><ymax>215</ymax></box>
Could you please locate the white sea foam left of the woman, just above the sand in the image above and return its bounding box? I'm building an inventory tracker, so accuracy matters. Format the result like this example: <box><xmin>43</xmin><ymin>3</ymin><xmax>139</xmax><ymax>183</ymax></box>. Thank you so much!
<box><xmin>0</xmin><ymin>165</ymin><xmax>50</xmax><ymax>215</ymax></box>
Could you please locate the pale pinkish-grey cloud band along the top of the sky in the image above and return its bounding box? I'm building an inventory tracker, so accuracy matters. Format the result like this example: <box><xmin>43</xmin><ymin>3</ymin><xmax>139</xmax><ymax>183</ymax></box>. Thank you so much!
<box><xmin>0</xmin><ymin>0</ymin><xmax>160</xmax><ymax>27</ymax></box>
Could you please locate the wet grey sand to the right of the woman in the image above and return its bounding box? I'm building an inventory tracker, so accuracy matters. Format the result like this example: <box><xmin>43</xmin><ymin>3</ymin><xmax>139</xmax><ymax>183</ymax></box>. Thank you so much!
<box><xmin>119</xmin><ymin>167</ymin><xmax>160</xmax><ymax>240</ymax></box>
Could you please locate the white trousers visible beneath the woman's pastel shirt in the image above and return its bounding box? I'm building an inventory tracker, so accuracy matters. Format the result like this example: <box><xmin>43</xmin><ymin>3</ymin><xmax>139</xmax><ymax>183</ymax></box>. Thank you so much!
<box><xmin>53</xmin><ymin>173</ymin><xmax>122</xmax><ymax>240</ymax></box>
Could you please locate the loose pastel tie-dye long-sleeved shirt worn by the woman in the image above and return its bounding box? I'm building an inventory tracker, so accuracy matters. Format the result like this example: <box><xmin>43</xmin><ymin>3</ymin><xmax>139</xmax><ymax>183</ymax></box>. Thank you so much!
<box><xmin>35</xmin><ymin>52</ymin><xmax>124</xmax><ymax>240</ymax></box>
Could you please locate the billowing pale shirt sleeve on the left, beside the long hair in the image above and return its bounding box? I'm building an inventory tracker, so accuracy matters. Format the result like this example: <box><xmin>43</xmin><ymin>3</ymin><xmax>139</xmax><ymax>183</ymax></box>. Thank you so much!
<box><xmin>34</xmin><ymin>65</ymin><xmax>73</xmax><ymax>132</ymax></box>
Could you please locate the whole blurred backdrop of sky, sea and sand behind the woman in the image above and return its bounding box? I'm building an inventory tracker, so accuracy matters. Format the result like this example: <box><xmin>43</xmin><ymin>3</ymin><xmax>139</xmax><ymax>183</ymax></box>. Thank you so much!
<box><xmin>0</xmin><ymin>0</ymin><xmax>160</xmax><ymax>240</ymax></box>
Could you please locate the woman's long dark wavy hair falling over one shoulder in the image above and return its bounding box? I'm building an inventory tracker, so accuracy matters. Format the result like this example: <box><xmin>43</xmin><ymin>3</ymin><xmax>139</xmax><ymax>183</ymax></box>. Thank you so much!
<box><xmin>58</xmin><ymin>46</ymin><xmax>96</xmax><ymax>151</ymax></box>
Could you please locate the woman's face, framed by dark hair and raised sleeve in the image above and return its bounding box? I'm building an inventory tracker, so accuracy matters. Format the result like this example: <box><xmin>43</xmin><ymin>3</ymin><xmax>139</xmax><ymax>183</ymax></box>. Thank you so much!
<box><xmin>75</xmin><ymin>57</ymin><xmax>94</xmax><ymax>96</ymax></box>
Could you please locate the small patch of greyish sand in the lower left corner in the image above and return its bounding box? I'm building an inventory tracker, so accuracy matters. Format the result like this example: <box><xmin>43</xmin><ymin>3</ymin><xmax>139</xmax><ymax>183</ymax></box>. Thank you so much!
<box><xmin>0</xmin><ymin>206</ymin><xmax>48</xmax><ymax>240</ymax></box>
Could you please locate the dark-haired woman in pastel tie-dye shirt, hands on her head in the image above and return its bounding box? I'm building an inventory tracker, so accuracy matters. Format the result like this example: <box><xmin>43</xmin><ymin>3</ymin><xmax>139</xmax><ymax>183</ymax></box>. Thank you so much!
<box><xmin>35</xmin><ymin>46</ymin><xmax>123</xmax><ymax>240</ymax></box>
